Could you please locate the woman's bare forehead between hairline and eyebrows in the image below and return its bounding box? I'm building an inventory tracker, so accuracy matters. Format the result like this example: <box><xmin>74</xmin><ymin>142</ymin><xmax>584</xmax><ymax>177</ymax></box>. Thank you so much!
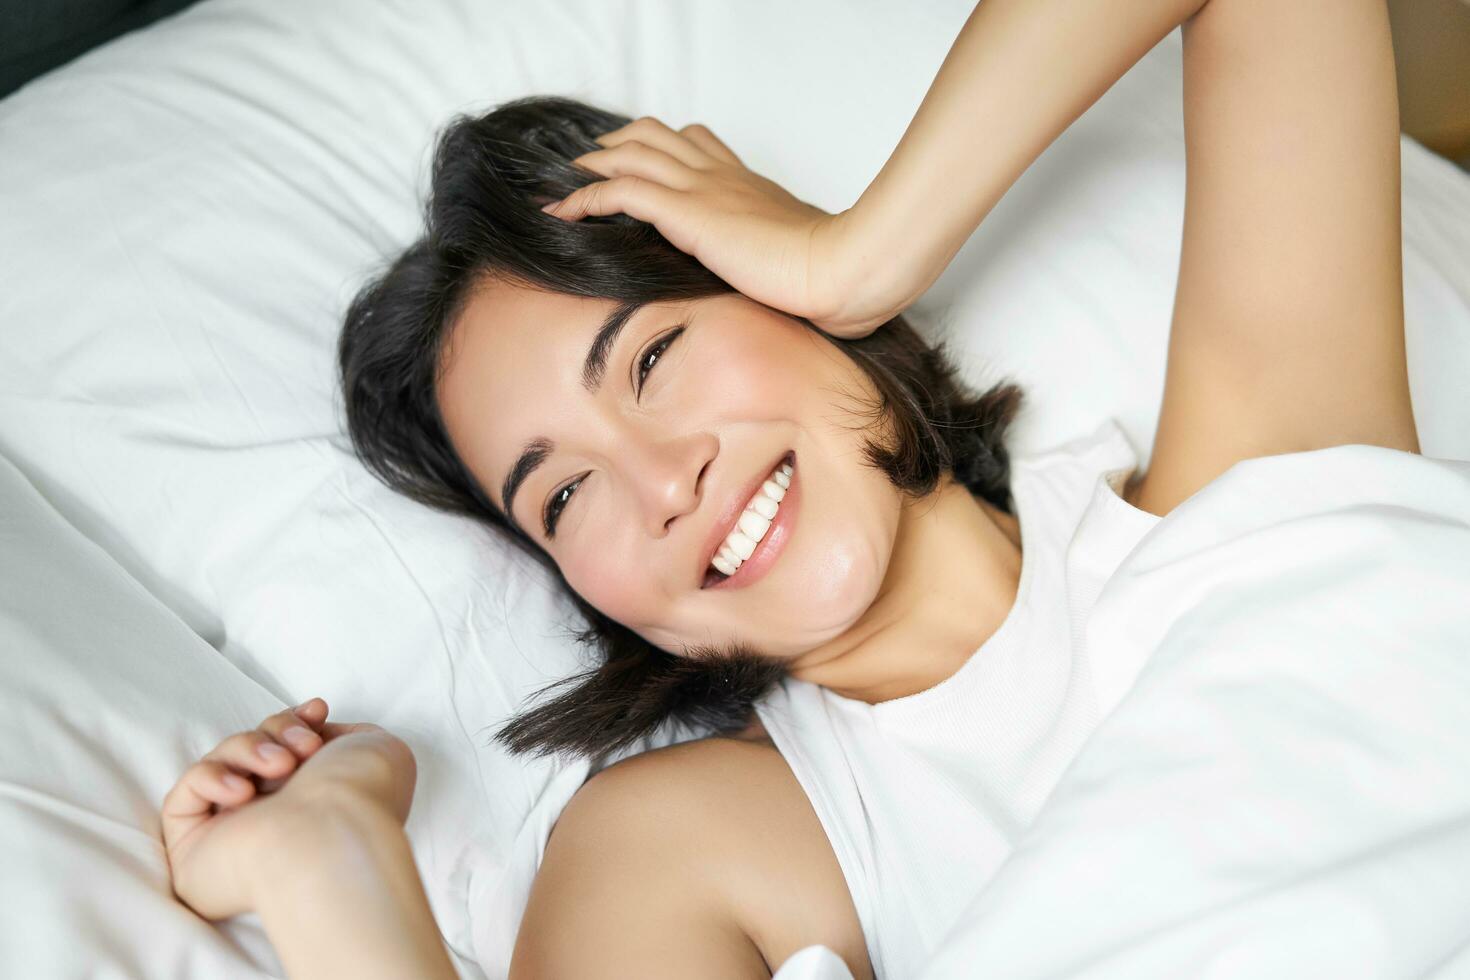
<box><xmin>435</xmin><ymin>281</ymin><xmax>641</xmax><ymax>514</ymax></box>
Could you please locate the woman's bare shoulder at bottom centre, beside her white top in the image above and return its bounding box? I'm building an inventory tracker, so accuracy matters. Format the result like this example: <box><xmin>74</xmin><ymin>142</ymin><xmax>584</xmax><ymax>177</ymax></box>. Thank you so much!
<box><xmin>512</xmin><ymin>729</ymin><xmax>872</xmax><ymax>980</ymax></box>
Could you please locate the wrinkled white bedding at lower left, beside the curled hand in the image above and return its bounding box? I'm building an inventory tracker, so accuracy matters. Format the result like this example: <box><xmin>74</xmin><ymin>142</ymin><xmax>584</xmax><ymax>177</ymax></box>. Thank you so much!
<box><xmin>0</xmin><ymin>457</ymin><xmax>282</xmax><ymax>977</ymax></box>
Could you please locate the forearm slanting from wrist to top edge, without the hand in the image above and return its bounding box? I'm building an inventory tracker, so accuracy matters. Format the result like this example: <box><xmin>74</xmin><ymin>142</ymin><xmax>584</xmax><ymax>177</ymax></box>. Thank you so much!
<box><xmin>845</xmin><ymin>0</ymin><xmax>1205</xmax><ymax>310</ymax></box>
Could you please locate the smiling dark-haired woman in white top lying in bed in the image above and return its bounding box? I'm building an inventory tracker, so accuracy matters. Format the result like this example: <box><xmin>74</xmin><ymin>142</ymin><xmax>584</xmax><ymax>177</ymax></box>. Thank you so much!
<box><xmin>163</xmin><ymin>0</ymin><xmax>1417</xmax><ymax>977</ymax></box>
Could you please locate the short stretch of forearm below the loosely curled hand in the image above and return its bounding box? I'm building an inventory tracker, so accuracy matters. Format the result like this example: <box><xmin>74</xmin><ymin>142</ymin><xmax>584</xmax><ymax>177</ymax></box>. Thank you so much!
<box><xmin>256</xmin><ymin>807</ymin><xmax>457</xmax><ymax>980</ymax></box>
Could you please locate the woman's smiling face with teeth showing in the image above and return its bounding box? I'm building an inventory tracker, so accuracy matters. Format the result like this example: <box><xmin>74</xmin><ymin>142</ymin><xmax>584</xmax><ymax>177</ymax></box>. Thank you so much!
<box><xmin>437</xmin><ymin>274</ymin><xmax>903</xmax><ymax>660</ymax></box>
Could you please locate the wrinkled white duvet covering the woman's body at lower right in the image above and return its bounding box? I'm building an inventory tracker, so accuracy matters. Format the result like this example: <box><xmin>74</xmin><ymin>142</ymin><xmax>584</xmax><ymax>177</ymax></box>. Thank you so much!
<box><xmin>778</xmin><ymin>445</ymin><xmax>1470</xmax><ymax>980</ymax></box>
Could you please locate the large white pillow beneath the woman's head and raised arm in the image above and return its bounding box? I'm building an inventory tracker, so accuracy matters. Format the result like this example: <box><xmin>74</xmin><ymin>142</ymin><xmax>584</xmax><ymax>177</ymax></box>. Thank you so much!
<box><xmin>0</xmin><ymin>0</ymin><xmax>1470</xmax><ymax>976</ymax></box>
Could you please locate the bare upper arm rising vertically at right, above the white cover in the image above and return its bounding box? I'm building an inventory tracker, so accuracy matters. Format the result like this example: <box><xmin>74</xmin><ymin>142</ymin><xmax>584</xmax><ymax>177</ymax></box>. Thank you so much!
<box><xmin>1133</xmin><ymin>0</ymin><xmax>1419</xmax><ymax>514</ymax></box>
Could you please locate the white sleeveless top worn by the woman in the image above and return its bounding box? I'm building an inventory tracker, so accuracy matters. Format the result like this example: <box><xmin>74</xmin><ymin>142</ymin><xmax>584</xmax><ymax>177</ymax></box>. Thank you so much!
<box><xmin>757</xmin><ymin>420</ymin><xmax>1160</xmax><ymax>979</ymax></box>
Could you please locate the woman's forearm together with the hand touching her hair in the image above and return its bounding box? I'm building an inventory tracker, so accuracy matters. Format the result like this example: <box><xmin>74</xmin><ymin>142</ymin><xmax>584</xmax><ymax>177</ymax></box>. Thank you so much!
<box><xmin>550</xmin><ymin>0</ymin><xmax>1205</xmax><ymax>336</ymax></box>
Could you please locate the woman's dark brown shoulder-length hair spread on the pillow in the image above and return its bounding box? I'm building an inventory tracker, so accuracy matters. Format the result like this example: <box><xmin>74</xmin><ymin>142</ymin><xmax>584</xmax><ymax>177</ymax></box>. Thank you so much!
<box><xmin>338</xmin><ymin>97</ymin><xmax>1022</xmax><ymax>757</ymax></box>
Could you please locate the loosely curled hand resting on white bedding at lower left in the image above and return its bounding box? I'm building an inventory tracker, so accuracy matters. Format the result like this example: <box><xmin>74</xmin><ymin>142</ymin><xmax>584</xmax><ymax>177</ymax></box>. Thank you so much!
<box><xmin>162</xmin><ymin>698</ymin><xmax>417</xmax><ymax>920</ymax></box>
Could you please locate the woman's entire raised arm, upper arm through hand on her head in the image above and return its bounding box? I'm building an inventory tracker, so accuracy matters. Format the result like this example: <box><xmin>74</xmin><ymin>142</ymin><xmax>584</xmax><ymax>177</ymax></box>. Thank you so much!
<box><xmin>553</xmin><ymin>0</ymin><xmax>1419</xmax><ymax>514</ymax></box>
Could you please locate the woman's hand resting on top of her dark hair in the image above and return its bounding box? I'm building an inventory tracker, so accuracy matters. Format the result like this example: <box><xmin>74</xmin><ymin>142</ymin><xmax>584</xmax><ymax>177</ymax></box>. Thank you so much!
<box><xmin>542</xmin><ymin>116</ymin><xmax>900</xmax><ymax>338</ymax></box>
